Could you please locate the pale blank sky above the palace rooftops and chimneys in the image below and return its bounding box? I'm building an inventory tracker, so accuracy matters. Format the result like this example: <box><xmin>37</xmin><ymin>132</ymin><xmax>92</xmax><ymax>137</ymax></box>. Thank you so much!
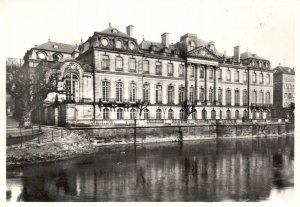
<box><xmin>0</xmin><ymin>0</ymin><xmax>299</xmax><ymax>67</ymax></box>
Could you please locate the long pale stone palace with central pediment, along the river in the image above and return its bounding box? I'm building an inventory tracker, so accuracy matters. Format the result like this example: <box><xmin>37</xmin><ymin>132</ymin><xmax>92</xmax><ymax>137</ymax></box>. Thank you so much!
<box><xmin>24</xmin><ymin>25</ymin><xmax>273</xmax><ymax>125</ymax></box>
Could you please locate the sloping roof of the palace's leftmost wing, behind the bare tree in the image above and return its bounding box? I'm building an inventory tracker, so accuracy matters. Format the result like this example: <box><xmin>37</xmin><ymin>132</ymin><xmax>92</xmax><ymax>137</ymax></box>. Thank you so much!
<box><xmin>33</xmin><ymin>41</ymin><xmax>77</xmax><ymax>53</ymax></box>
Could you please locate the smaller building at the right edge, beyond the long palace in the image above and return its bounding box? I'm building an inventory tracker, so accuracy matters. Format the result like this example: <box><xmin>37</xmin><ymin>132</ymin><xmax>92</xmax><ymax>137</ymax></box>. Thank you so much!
<box><xmin>273</xmin><ymin>66</ymin><xmax>295</xmax><ymax>118</ymax></box>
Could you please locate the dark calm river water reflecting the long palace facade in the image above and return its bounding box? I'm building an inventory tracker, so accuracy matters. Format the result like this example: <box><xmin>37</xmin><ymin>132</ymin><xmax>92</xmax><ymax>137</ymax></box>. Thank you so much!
<box><xmin>7</xmin><ymin>137</ymin><xmax>294</xmax><ymax>201</ymax></box>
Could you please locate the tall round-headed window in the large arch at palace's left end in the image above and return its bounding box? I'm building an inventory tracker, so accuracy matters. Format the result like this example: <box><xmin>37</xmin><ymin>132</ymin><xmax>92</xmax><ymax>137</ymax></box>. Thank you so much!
<box><xmin>65</xmin><ymin>72</ymin><xmax>79</xmax><ymax>101</ymax></box>
